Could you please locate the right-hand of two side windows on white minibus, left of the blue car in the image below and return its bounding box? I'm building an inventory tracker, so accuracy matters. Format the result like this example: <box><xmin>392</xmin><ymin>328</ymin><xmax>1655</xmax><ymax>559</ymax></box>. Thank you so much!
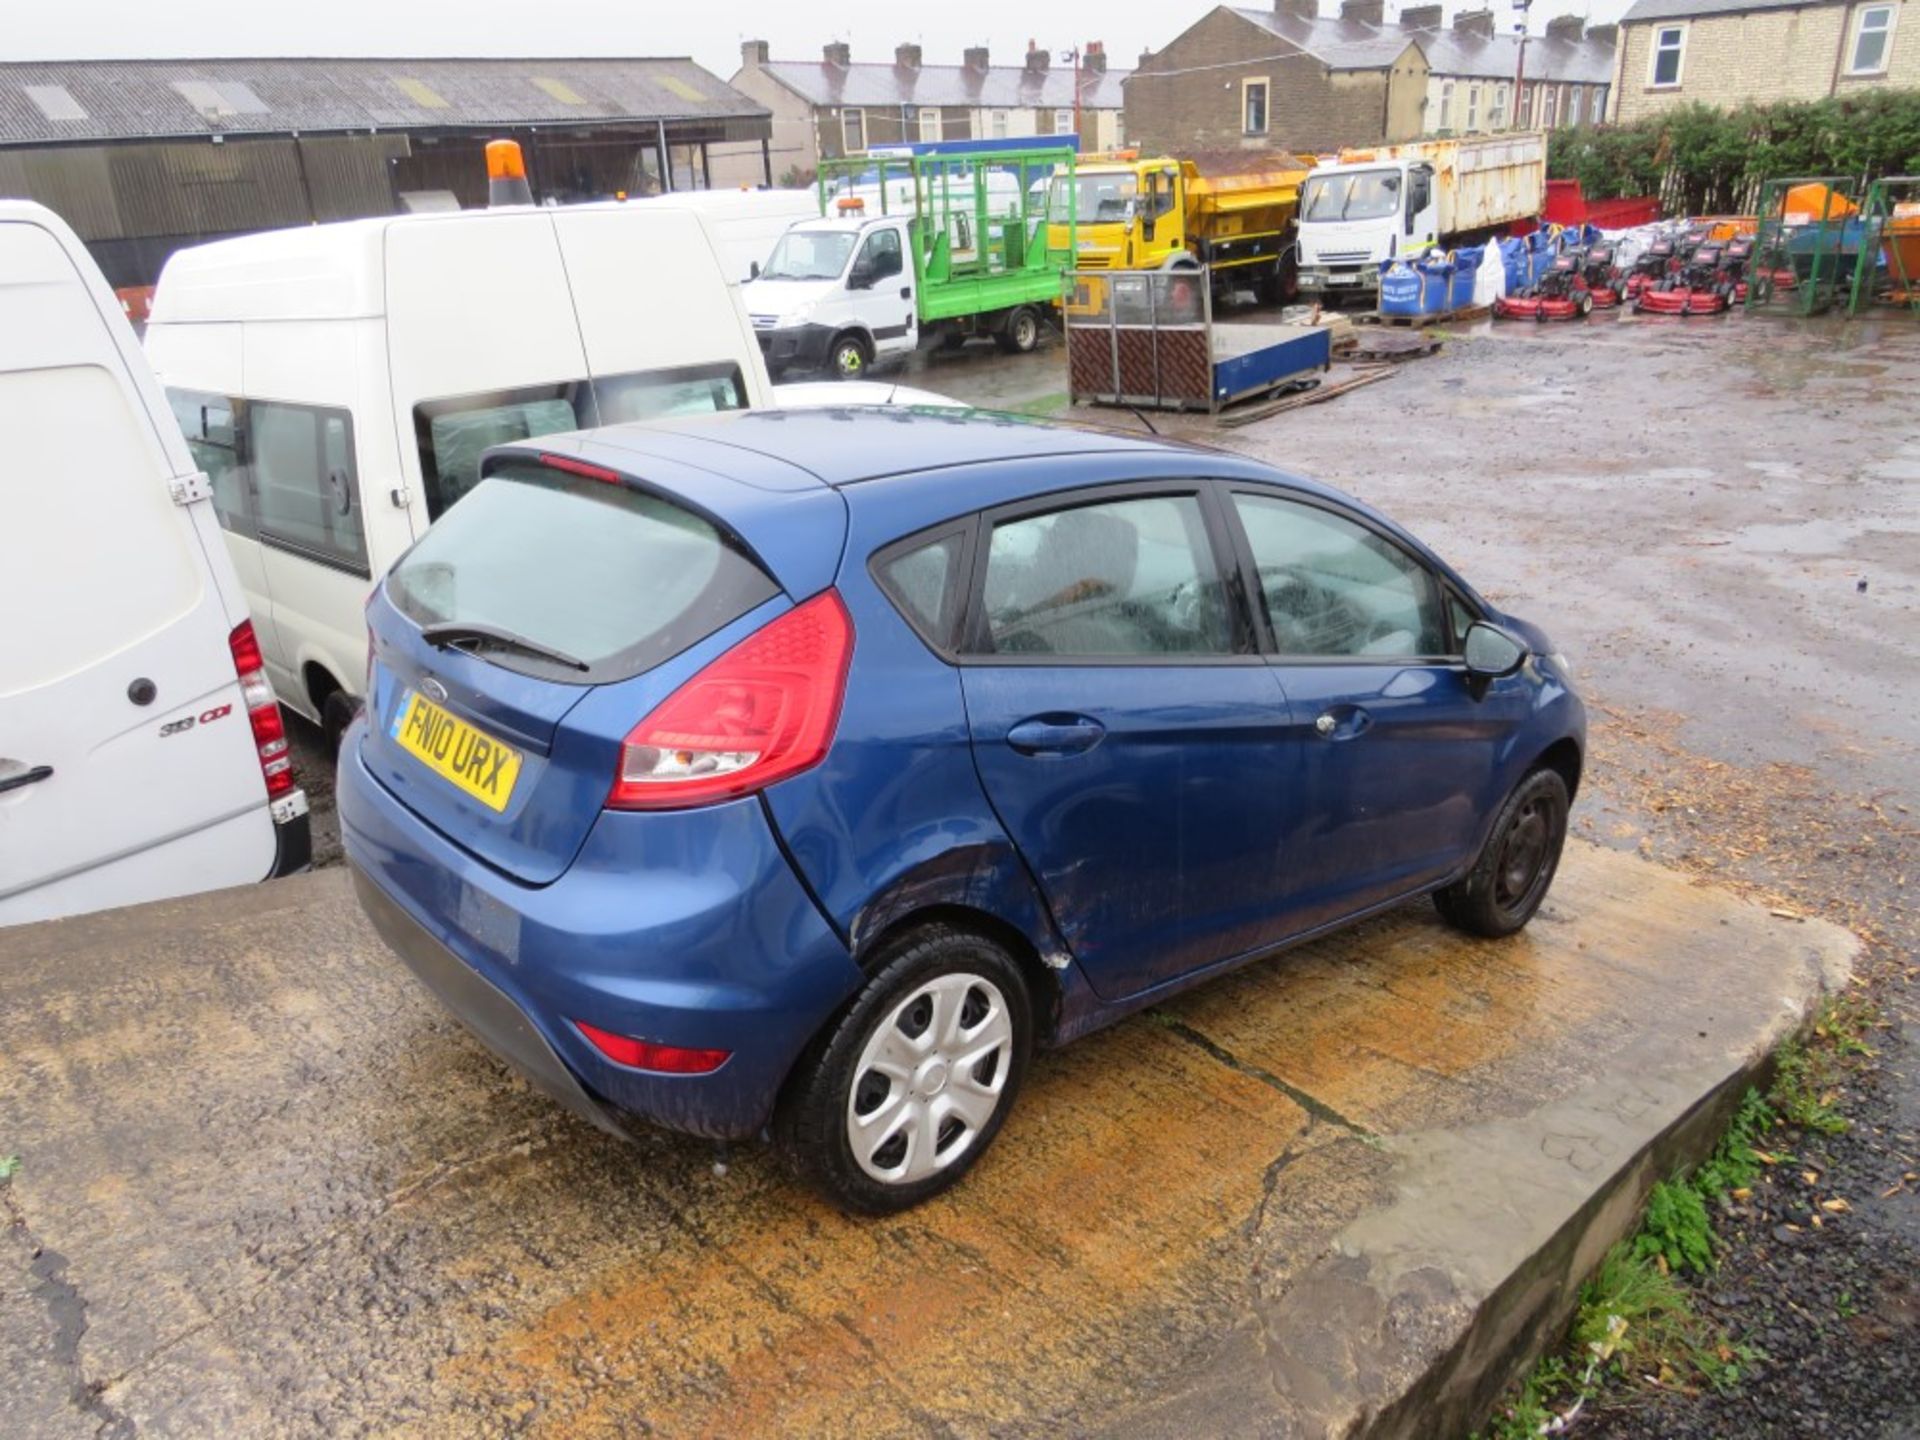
<box><xmin>248</xmin><ymin>399</ymin><xmax>369</xmax><ymax>574</ymax></box>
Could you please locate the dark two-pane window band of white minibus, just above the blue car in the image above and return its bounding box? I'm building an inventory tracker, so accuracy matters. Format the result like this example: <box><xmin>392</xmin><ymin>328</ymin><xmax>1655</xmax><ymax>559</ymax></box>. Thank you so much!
<box><xmin>413</xmin><ymin>363</ymin><xmax>747</xmax><ymax>520</ymax></box>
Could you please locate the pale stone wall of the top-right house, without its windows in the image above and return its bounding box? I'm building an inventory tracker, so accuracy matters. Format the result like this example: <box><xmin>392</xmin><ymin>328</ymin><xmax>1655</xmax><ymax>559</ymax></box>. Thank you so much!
<box><xmin>1615</xmin><ymin>0</ymin><xmax>1920</xmax><ymax>123</ymax></box>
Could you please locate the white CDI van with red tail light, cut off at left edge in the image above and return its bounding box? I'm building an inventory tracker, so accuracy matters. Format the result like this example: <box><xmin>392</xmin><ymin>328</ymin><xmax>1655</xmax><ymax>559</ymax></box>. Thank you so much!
<box><xmin>0</xmin><ymin>200</ymin><xmax>309</xmax><ymax>925</ymax></box>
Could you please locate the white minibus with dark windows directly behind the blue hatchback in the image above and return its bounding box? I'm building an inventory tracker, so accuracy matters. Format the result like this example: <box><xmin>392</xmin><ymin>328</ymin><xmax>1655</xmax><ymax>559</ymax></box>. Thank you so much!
<box><xmin>146</xmin><ymin>202</ymin><xmax>772</xmax><ymax>737</ymax></box>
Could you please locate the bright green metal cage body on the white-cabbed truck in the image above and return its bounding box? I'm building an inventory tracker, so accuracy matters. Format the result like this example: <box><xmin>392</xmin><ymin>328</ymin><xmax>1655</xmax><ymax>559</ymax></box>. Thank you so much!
<box><xmin>816</xmin><ymin>146</ymin><xmax>1079</xmax><ymax>321</ymax></box>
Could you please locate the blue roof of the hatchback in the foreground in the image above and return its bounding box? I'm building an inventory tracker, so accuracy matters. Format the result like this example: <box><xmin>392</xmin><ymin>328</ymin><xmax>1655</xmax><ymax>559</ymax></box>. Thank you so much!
<box><xmin>560</xmin><ymin>405</ymin><xmax>1198</xmax><ymax>488</ymax></box>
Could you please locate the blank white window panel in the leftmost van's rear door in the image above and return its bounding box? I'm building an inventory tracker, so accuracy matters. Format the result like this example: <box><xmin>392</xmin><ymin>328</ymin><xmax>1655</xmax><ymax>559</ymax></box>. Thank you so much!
<box><xmin>0</xmin><ymin>365</ymin><xmax>200</xmax><ymax>695</ymax></box>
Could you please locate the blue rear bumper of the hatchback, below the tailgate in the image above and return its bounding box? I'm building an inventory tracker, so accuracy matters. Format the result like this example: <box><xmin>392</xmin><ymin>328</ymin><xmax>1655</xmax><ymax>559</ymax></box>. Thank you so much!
<box><xmin>338</xmin><ymin>720</ymin><xmax>860</xmax><ymax>1139</ymax></box>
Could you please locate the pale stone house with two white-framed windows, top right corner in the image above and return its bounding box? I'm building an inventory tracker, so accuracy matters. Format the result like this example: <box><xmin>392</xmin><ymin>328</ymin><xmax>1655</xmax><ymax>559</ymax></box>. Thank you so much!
<box><xmin>1613</xmin><ymin>0</ymin><xmax>1920</xmax><ymax>121</ymax></box>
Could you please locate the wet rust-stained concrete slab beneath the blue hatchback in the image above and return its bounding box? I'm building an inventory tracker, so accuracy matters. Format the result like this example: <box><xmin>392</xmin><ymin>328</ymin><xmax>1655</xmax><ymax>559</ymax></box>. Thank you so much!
<box><xmin>0</xmin><ymin>847</ymin><xmax>1853</xmax><ymax>1436</ymax></box>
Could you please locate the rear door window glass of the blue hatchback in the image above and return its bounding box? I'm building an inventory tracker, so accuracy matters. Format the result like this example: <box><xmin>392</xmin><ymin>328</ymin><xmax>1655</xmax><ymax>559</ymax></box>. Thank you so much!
<box><xmin>985</xmin><ymin>495</ymin><xmax>1233</xmax><ymax>657</ymax></box>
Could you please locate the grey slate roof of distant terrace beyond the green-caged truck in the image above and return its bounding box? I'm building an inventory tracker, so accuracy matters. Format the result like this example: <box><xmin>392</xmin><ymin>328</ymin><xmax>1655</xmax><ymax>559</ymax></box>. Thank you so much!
<box><xmin>760</xmin><ymin>60</ymin><xmax>1133</xmax><ymax>109</ymax></box>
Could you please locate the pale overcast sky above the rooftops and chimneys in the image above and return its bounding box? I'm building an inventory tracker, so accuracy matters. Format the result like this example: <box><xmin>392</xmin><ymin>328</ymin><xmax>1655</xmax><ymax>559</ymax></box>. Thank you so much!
<box><xmin>11</xmin><ymin>0</ymin><xmax>1628</xmax><ymax>79</ymax></box>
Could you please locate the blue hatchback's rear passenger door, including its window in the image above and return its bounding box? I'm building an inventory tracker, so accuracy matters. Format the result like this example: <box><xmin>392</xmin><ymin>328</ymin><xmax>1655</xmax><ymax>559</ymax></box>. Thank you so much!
<box><xmin>960</xmin><ymin>484</ymin><xmax>1298</xmax><ymax>1000</ymax></box>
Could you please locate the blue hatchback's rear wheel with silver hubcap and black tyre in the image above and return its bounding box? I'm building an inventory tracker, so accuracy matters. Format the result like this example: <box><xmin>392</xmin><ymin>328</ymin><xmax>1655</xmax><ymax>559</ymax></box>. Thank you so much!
<box><xmin>776</xmin><ymin>925</ymin><xmax>1033</xmax><ymax>1215</ymax></box>
